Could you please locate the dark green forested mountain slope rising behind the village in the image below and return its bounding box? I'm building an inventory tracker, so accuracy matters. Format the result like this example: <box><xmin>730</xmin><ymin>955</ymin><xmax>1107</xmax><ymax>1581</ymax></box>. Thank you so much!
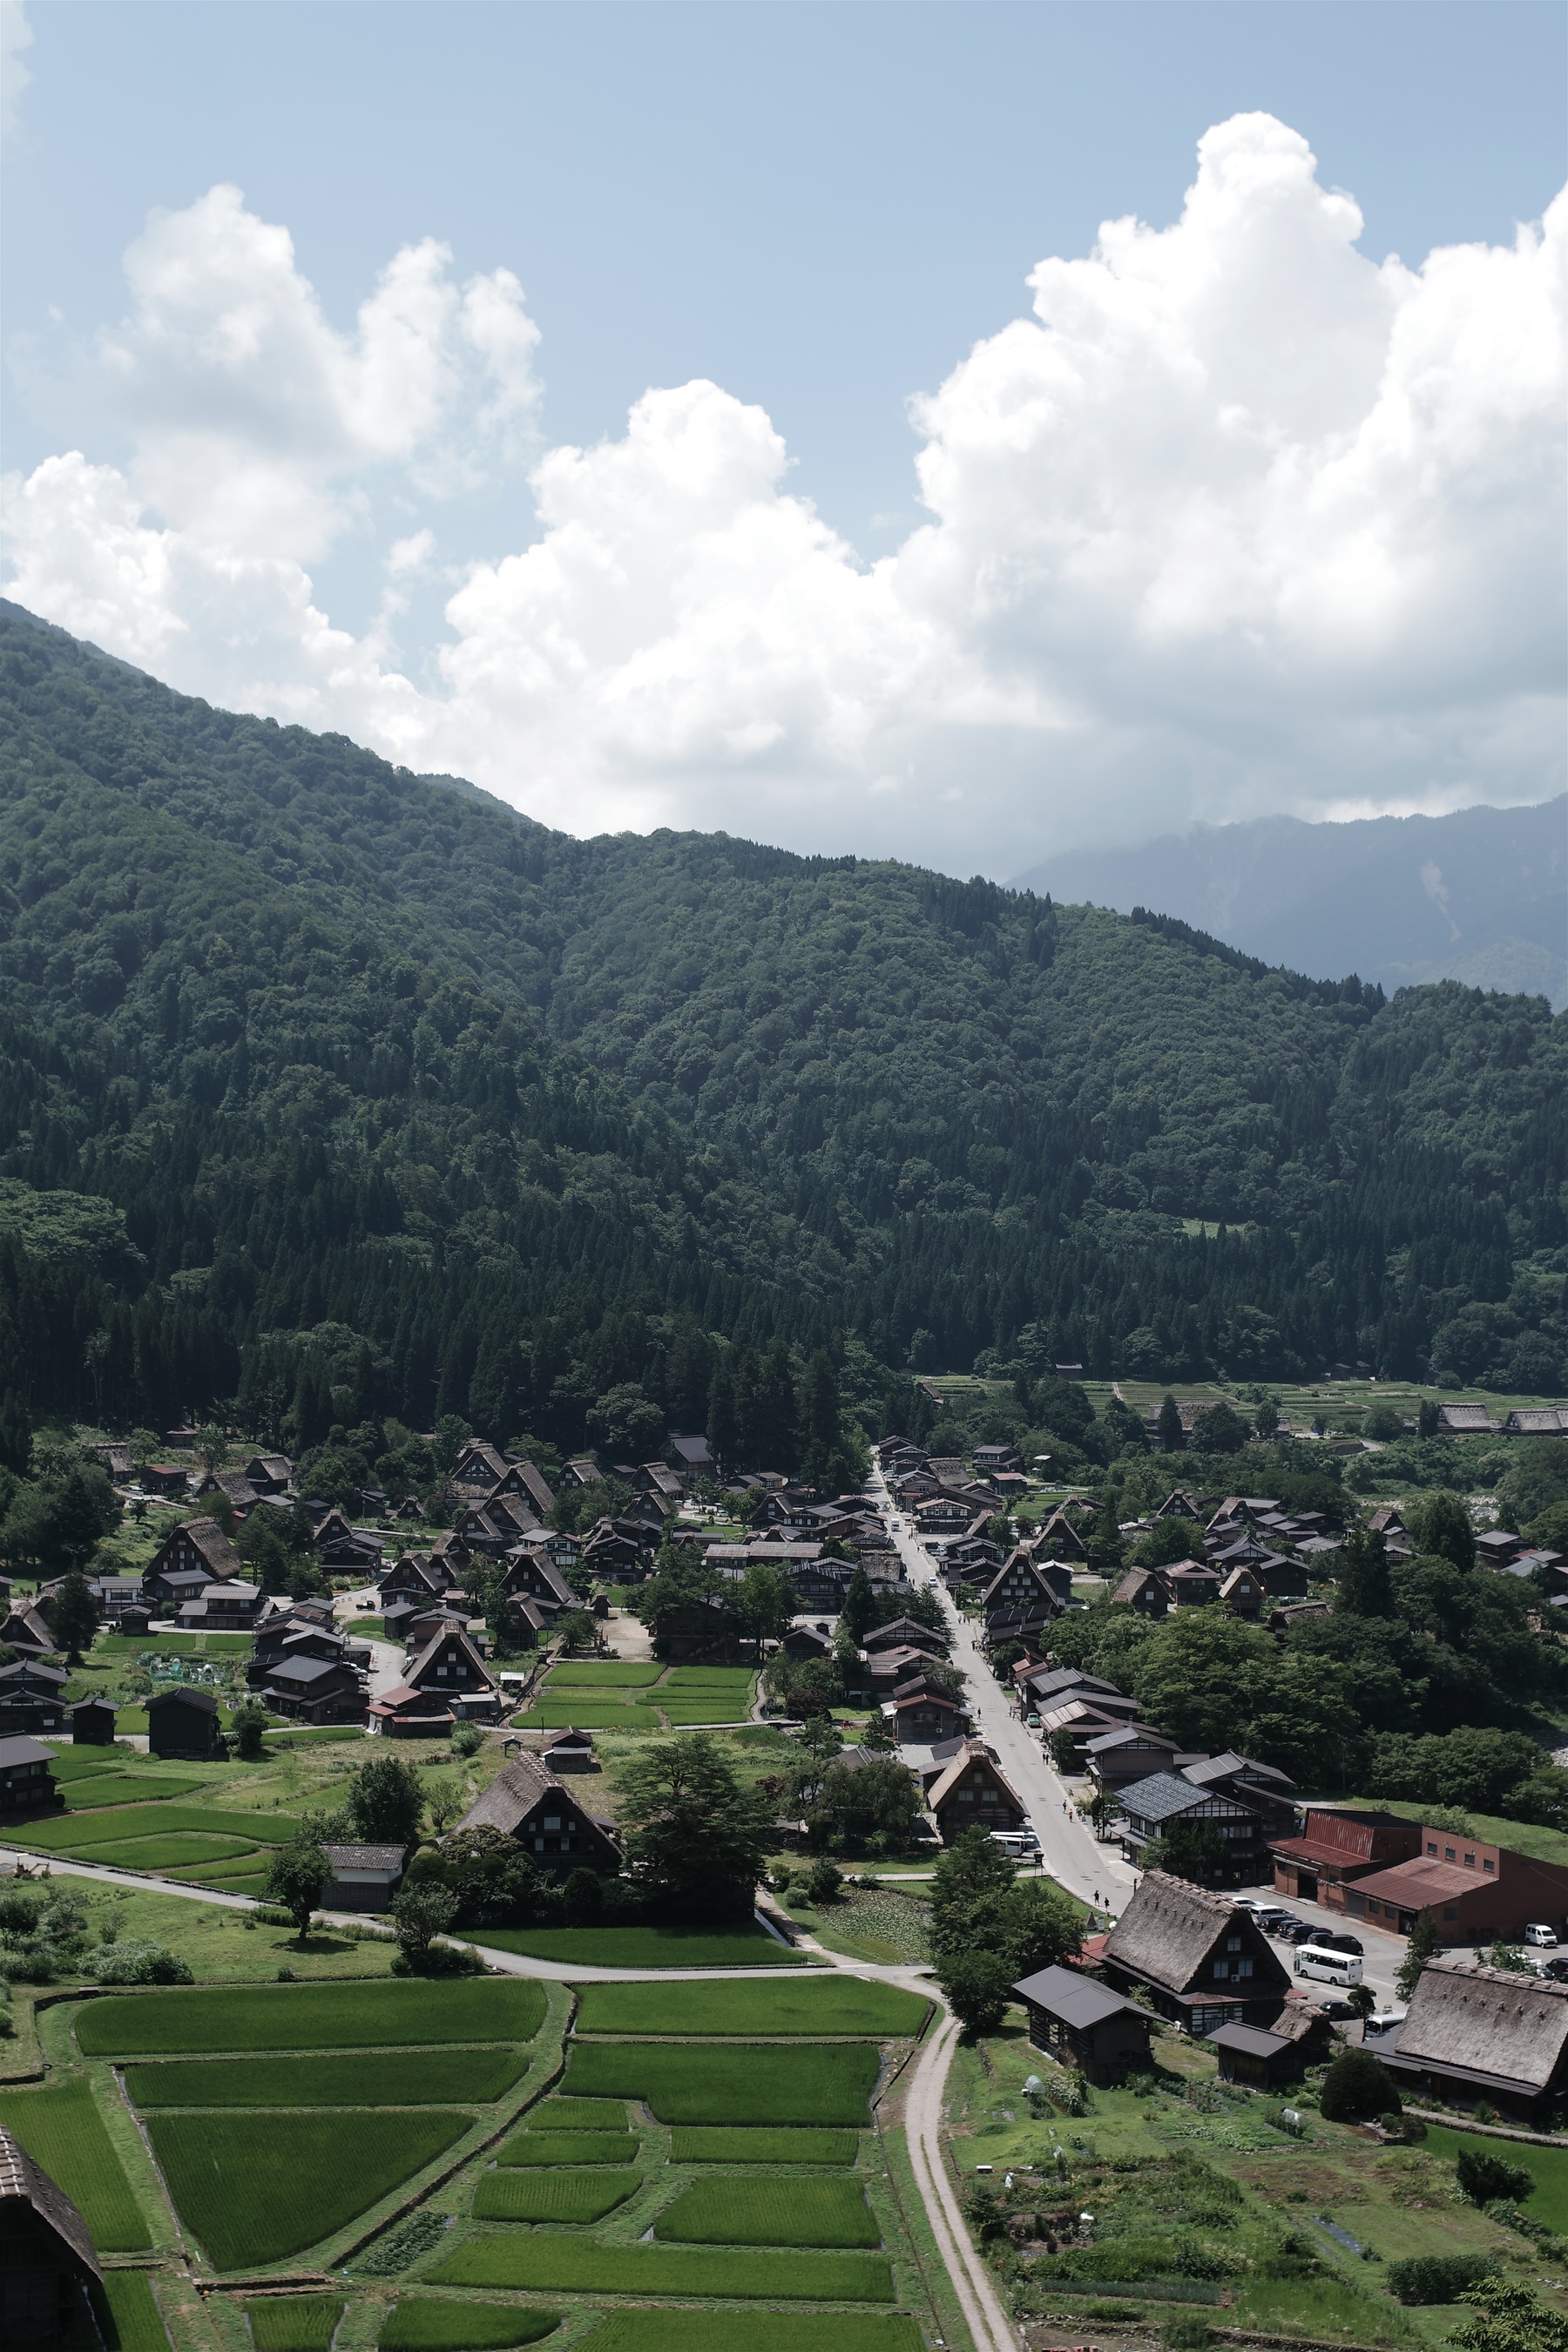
<box><xmin>0</xmin><ymin>607</ymin><xmax>1568</xmax><ymax>1444</ymax></box>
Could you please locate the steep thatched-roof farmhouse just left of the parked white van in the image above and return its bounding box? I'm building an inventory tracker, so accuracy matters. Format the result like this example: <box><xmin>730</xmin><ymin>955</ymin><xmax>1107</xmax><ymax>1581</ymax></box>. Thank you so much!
<box><xmin>1103</xmin><ymin>1870</ymin><xmax>1291</xmax><ymax>2039</ymax></box>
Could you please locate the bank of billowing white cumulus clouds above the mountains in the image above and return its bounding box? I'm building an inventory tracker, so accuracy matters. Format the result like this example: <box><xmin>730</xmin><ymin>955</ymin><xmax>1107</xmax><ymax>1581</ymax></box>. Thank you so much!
<box><xmin>10</xmin><ymin>115</ymin><xmax>1568</xmax><ymax>873</ymax></box>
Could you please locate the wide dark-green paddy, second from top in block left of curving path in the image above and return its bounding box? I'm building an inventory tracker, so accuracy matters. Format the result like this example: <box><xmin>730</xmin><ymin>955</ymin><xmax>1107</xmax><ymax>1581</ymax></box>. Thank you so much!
<box><xmin>564</xmin><ymin>2042</ymin><xmax>882</xmax><ymax>2129</ymax></box>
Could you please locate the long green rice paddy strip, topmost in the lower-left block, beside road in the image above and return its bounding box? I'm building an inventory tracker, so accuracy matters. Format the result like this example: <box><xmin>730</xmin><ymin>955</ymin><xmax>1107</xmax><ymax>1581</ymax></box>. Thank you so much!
<box><xmin>75</xmin><ymin>1978</ymin><xmax>545</xmax><ymax>2058</ymax></box>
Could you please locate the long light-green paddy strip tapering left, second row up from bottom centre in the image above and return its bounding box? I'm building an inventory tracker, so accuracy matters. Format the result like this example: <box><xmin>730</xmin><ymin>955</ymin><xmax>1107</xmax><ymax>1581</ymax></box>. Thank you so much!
<box><xmin>425</xmin><ymin>2230</ymin><xmax>893</xmax><ymax>2295</ymax></box>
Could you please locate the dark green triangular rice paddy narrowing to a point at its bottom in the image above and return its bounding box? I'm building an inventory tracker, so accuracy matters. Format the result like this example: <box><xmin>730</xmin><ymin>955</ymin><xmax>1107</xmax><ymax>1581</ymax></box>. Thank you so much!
<box><xmin>148</xmin><ymin>2107</ymin><xmax>472</xmax><ymax>2270</ymax></box>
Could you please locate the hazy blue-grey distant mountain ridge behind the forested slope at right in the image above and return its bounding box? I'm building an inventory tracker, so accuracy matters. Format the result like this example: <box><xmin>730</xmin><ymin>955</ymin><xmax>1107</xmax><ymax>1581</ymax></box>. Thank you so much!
<box><xmin>1013</xmin><ymin>793</ymin><xmax>1568</xmax><ymax>1011</ymax></box>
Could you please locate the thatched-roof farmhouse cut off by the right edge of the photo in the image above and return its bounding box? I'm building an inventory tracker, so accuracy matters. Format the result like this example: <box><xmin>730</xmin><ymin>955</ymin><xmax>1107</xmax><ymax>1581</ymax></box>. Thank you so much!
<box><xmin>1377</xmin><ymin>1959</ymin><xmax>1568</xmax><ymax>2126</ymax></box>
